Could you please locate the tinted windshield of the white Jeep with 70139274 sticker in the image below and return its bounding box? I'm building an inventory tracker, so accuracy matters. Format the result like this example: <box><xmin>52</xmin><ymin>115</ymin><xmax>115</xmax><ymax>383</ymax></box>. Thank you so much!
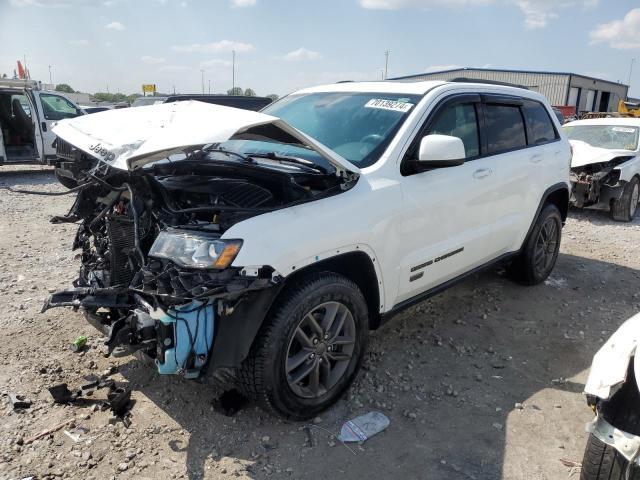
<box><xmin>262</xmin><ymin>92</ymin><xmax>421</xmax><ymax>168</ymax></box>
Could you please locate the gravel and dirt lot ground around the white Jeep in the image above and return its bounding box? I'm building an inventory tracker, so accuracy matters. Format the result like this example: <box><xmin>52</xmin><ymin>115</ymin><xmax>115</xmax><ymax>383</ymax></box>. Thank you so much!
<box><xmin>0</xmin><ymin>167</ymin><xmax>640</xmax><ymax>480</ymax></box>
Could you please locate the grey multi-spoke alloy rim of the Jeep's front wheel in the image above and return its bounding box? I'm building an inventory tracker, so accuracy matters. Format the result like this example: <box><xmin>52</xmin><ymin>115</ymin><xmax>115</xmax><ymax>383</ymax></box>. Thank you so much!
<box><xmin>285</xmin><ymin>301</ymin><xmax>356</xmax><ymax>398</ymax></box>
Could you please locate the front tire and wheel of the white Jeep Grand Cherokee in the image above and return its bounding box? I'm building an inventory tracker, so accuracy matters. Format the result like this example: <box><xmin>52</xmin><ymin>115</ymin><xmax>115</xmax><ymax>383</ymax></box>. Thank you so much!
<box><xmin>238</xmin><ymin>272</ymin><xmax>369</xmax><ymax>420</ymax></box>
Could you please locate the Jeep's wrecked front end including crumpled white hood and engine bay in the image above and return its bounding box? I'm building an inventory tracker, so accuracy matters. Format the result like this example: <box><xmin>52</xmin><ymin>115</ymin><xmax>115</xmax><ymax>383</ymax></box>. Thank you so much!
<box><xmin>43</xmin><ymin>102</ymin><xmax>353</xmax><ymax>379</ymax></box>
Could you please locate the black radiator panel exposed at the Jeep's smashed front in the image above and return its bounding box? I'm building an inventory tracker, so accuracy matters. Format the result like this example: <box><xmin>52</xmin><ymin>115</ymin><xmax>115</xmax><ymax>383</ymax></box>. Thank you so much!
<box><xmin>107</xmin><ymin>215</ymin><xmax>135</xmax><ymax>286</ymax></box>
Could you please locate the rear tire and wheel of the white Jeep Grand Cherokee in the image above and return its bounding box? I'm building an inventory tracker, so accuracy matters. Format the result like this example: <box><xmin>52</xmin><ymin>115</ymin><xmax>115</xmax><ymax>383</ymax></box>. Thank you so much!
<box><xmin>508</xmin><ymin>203</ymin><xmax>562</xmax><ymax>285</ymax></box>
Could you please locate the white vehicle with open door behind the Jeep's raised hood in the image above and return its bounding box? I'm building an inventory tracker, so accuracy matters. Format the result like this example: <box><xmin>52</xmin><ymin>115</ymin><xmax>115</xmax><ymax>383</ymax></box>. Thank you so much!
<box><xmin>0</xmin><ymin>79</ymin><xmax>84</xmax><ymax>165</ymax></box>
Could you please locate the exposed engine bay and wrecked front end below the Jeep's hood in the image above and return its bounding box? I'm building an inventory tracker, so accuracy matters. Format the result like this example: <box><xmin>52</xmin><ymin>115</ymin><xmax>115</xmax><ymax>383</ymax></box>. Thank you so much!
<box><xmin>43</xmin><ymin>138</ymin><xmax>349</xmax><ymax>378</ymax></box>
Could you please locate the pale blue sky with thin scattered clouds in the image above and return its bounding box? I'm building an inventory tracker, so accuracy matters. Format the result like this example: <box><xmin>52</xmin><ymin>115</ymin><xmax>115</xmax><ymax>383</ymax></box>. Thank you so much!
<box><xmin>0</xmin><ymin>0</ymin><xmax>640</xmax><ymax>96</ymax></box>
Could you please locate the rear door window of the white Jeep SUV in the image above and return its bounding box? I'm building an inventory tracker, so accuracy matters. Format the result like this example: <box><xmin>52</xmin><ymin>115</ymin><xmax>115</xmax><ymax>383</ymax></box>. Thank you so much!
<box><xmin>484</xmin><ymin>104</ymin><xmax>527</xmax><ymax>155</ymax></box>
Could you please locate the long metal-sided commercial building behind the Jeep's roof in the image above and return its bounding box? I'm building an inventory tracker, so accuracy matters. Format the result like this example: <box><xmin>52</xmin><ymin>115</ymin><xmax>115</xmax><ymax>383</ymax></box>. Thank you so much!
<box><xmin>393</xmin><ymin>68</ymin><xmax>629</xmax><ymax>115</ymax></box>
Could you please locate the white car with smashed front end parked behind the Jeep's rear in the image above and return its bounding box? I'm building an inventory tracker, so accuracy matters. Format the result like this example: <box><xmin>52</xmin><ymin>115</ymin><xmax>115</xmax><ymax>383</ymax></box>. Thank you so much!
<box><xmin>563</xmin><ymin>118</ymin><xmax>640</xmax><ymax>222</ymax></box>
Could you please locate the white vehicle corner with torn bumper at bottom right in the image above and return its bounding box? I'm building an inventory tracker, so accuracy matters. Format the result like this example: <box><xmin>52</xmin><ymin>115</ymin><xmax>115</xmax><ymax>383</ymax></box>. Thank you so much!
<box><xmin>580</xmin><ymin>314</ymin><xmax>640</xmax><ymax>480</ymax></box>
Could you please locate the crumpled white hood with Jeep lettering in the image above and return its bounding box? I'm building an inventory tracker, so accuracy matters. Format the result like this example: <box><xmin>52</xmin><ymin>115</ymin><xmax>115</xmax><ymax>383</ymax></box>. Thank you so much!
<box><xmin>52</xmin><ymin>100</ymin><xmax>360</xmax><ymax>175</ymax></box>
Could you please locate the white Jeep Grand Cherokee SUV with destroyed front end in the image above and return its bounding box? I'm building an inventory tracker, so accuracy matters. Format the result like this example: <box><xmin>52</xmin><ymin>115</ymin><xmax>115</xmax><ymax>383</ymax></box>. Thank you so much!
<box><xmin>44</xmin><ymin>82</ymin><xmax>571</xmax><ymax>419</ymax></box>
